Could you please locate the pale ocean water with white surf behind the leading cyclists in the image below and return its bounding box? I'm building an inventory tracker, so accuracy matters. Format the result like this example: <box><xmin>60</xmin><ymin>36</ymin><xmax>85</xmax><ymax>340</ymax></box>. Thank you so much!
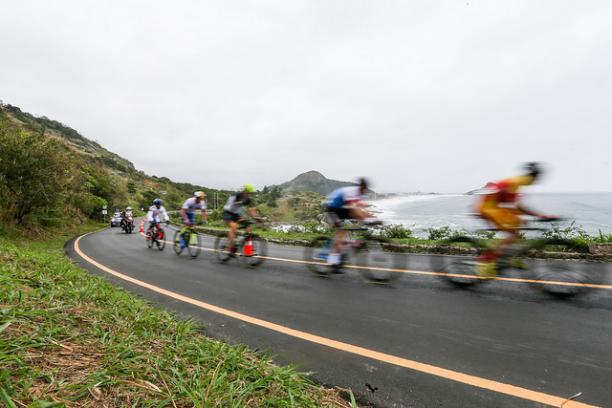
<box><xmin>372</xmin><ymin>193</ymin><xmax>612</xmax><ymax>236</ymax></box>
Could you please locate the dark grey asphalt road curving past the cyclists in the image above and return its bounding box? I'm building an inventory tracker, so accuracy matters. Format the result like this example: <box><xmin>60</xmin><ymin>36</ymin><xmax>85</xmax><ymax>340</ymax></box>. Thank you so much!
<box><xmin>66</xmin><ymin>228</ymin><xmax>612</xmax><ymax>408</ymax></box>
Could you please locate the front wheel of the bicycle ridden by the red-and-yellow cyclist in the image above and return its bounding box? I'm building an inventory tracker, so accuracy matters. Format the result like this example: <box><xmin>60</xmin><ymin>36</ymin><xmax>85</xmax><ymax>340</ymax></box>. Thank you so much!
<box><xmin>518</xmin><ymin>239</ymin><xmax>600</xmax><ymax>298</ymax></box>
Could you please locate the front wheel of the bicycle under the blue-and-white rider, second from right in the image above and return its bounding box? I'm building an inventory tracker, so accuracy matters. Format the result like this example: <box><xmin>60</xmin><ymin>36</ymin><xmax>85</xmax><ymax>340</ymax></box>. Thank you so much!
<box><xmin>355</xmin><ymin>238</ymin><xmax>406</xmax><ymax>283</ymax></box>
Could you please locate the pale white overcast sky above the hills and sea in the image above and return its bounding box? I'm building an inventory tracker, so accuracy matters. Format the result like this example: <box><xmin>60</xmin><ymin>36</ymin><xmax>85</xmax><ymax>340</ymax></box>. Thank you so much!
<box><xmin>0</xmin><ymin>0</ymin><xmax>612</xmax><ymax>192</ymax></box>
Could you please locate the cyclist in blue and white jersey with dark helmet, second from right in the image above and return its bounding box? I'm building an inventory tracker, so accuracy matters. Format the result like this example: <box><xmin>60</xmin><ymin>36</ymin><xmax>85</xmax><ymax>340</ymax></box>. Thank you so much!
<box><xmin>326</xmin><ymin>178</ymin><xmax>372</xmax><ymax>266</ymax></box>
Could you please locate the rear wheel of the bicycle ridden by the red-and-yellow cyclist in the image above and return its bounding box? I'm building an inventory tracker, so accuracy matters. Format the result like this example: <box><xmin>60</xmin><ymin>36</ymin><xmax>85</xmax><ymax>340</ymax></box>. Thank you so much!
<box><xmin>431</xmin><ymin>237</ymin><xmax>487</xmax><ymax>287</ymax></box>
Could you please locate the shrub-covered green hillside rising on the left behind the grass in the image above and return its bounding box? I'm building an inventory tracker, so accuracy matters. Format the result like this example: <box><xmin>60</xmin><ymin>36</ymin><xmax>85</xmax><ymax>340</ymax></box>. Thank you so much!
<box><xmin>0</xmin><ymin>100</ymin><xmax>230</xmax><ymax>225</ymax></box>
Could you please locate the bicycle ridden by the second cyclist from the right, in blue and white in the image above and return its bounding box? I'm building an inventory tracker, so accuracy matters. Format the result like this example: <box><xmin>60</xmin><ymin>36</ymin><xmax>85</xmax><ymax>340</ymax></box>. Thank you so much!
<box><xmin>304</xmin><ymin>222</ymin><xmax>405</xmax><ymax>283</ymax></box>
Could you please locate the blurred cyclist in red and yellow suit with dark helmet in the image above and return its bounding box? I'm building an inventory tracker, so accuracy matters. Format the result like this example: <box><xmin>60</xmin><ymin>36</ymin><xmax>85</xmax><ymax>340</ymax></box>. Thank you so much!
<box><xmin>476</xmin><ymin>162</ymin><xmax>558</xmax><ymax>277</ymax></box>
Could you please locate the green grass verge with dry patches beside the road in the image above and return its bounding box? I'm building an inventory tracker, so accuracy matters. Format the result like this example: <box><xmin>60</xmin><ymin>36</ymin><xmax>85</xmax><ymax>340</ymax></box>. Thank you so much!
<box><xmin>0</xmin><ymin>224</ymin><xmax>349</xmax><ymax>408</ymax></box>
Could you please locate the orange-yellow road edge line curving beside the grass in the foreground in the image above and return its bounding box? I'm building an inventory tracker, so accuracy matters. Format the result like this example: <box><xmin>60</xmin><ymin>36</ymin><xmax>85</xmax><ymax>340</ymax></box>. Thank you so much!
<box><xmin>74</xmin><ymin>234</ymin><xmax>596</xmax><ymax>408</ymax></box>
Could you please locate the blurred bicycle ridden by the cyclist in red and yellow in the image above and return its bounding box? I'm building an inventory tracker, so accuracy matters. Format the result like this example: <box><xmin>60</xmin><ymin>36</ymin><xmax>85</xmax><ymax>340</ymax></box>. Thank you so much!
<box><xmin>431</xmin><ymin>219</ymin><xmax>594</xmax><ymax>297</ymax></box>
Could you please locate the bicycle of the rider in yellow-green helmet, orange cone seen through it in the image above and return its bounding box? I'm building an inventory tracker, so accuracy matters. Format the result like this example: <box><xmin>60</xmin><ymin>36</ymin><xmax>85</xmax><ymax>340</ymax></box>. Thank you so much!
<box><xmin>215</xmin><ymin>220</ymin><xmax>268</xmax><ymax>268</ymax></box>
